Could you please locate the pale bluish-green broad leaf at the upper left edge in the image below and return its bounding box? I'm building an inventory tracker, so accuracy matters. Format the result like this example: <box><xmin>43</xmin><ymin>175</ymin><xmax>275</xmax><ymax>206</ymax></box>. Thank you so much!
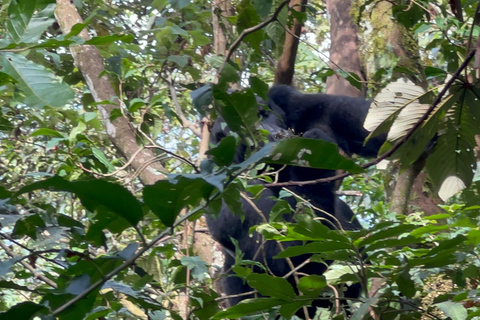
<box><xmin>0</xmin><ymin>53</ymin><xmax>74</xmax><ymax>108</ymax></box>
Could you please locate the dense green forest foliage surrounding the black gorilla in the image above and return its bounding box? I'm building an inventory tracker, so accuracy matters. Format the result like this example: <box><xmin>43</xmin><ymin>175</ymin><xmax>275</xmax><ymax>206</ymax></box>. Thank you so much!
<box><xmin>0</xmin><ymin>0</ymin><xmax>480</xmax><ymax>319</ymax></box>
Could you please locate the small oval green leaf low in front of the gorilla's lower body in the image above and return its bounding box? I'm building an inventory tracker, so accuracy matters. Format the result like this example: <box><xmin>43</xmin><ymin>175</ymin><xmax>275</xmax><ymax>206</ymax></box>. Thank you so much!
<box><xmin>247</xmin><ymin>273</ymin><xmax>295</xmax><ymax>300</ymax></box>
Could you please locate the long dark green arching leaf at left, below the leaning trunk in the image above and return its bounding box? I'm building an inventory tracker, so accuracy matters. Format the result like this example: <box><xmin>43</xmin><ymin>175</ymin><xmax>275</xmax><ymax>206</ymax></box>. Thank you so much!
<box><xmin>16</xmin><ymin>176</ymin><xmax>143</xmax><ymax>228</ymax></box>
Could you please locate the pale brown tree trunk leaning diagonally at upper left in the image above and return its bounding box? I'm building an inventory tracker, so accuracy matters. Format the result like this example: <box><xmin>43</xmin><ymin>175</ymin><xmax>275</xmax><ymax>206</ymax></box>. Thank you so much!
<box><xmin>55</xmin><ymin>0</ymin><xmax>165</xmax><ymax>184</ymax></box>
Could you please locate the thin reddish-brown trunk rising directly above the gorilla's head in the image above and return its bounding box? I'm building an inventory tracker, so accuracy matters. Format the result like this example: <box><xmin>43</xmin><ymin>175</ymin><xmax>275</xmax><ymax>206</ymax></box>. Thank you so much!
<box><xmin>274</xmin><ymin>0</ymin><xmax>307</xmax><ymax>85</ymax></box>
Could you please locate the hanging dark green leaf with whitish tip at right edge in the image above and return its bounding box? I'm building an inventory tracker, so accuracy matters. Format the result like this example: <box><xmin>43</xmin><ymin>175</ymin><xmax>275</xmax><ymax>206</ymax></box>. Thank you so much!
<box><xmin>427</xmin><ymin>89</ymin><xmax>479</xmax><ymax>200</ymax></box>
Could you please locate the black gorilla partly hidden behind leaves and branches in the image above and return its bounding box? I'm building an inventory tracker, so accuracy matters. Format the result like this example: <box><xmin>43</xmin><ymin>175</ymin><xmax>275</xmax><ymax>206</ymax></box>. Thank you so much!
<box><xmin>207</xmin><ymin>86</ymin><xmax>383</xmax><ymax>316</ymax></box>
